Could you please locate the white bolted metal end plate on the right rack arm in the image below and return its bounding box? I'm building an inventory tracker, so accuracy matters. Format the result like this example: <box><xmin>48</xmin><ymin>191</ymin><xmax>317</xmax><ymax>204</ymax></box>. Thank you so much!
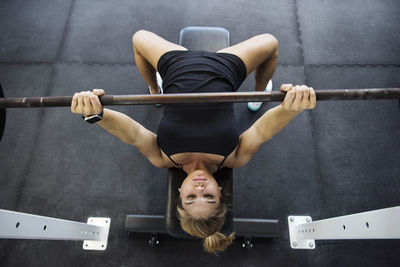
<box><xmin>288</xmin><ymin>216</ymin><xmax>315</xmax><ymax>249</ymax></box>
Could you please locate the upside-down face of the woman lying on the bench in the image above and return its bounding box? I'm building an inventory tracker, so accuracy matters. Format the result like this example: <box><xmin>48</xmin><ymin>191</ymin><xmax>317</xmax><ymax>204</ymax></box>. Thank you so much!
<box><xmin>178</xmin><ymin>170</ymin><xmax>221</xmax><ymax>218</ymax></box>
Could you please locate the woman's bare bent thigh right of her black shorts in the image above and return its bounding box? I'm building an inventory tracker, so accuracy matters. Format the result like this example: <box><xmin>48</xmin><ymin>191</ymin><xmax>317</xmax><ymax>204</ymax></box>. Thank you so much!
<box><xmin>218</xmin><ymin>34</ymin><xmax>278</xmax><ymax>75</ymax></box>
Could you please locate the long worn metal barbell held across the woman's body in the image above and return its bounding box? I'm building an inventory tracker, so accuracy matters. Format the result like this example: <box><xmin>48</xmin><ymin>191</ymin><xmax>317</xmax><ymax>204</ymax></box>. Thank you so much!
<box><xmin>0</xmin><ymin>84</ymin><xmax>400</xmax><ymax>144</ymax></box>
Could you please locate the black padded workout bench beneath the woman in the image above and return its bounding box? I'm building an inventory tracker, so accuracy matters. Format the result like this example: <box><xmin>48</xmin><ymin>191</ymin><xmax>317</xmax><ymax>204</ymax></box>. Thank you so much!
<box><xmin>125</xmin><ymin>27</ymin><xmax>278</xmax><ymax>249</ymax></box>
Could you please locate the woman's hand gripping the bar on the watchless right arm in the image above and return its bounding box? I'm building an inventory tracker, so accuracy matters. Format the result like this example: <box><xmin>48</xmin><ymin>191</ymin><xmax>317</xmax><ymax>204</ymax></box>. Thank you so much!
<box><xmin>281</xmin><ymin>84</ymin><xmax>317</xmax><ymax>112</ymax></box>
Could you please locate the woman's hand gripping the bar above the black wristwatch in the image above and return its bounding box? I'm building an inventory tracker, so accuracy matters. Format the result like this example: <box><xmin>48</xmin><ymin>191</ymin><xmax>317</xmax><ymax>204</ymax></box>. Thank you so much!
<box><xmin>71</xmin><ymin>89</ymin><xmax>105</xmax><ymax>117</ymax></box>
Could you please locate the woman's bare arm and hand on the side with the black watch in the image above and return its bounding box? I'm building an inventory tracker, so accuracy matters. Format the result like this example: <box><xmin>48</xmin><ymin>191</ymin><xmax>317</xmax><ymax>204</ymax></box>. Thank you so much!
<box><xmin>71</xmin><ymin>89</ymin><xmax>166</xmax><ymax>168</ymax></box>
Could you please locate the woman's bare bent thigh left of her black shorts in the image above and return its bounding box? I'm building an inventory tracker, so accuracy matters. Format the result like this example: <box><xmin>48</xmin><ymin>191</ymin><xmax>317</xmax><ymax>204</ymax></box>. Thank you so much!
<box><xmin>132</xmin><ymin>30</ymin><xmax>187</xmax><ymax>69</ymax></box>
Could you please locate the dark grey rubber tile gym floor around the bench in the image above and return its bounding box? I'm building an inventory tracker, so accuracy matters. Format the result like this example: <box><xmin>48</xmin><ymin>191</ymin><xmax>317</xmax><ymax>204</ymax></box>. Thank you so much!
<box><xmin>0</xmin><ymin>0</ymin><xmax>400</xmax><ymax>266</ymax></box>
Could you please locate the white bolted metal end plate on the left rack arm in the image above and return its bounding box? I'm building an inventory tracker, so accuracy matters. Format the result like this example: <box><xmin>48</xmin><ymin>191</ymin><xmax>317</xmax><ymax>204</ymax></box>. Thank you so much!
<box><xmin>83</xmin><ymin>217</ymin><xmax>111</xmax><ymax>250</ymax></box>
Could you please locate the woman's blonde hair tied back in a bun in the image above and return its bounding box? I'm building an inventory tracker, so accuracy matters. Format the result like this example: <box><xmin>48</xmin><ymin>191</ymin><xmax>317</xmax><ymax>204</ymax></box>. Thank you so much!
<box><xmin>177</xmin><ymin>203</ymin><xmax>235</xmax><ymax>255</ymax></box>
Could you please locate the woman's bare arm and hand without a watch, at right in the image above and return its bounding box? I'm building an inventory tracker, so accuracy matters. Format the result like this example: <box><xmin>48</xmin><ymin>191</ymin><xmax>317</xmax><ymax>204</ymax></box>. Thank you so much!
<box><xmin>226</xmin><ymin>84</ymin><xmax>316</xmax><ymax>168</ymax></box>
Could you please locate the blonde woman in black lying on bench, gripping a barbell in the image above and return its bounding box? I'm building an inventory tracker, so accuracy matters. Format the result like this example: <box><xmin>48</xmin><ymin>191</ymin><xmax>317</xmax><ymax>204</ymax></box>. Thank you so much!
<box><xmin>71</xmin><ymin>30</ymin><xmax>316</xmax><ymax>253</ymax></box>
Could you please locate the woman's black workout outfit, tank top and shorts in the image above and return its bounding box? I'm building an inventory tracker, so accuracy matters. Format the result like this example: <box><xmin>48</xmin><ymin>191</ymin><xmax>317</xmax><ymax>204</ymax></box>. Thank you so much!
<box><xmin>157</xmin><ymin>51</ymin><xmax>246</xmax><ymax>165</ymax></box>
